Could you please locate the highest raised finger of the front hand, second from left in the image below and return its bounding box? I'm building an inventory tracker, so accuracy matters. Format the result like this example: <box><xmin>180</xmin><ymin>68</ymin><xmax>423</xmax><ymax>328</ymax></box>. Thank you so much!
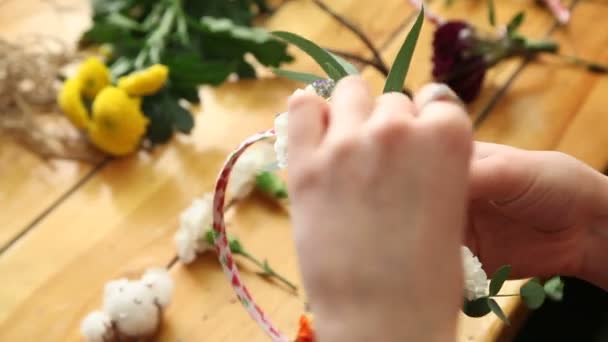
<box><xmin>327</xmin><ymin>76</ymin><xmax>373</xmax><ymax>140</ymax></box>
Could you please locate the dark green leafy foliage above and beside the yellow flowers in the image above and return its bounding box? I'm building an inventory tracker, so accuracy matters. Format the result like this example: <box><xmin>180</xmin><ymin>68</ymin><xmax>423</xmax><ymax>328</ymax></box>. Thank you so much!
<box><xmin>80</xmin><ymin>0</ymin><xmax>292</xmax><ymax>143</ymax></box>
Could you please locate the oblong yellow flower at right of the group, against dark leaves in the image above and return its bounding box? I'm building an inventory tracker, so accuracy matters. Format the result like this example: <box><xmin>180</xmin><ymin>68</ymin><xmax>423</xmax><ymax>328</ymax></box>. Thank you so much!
<box><xmin>118</xmin><ymin>64</ymin><xmax>169</xmax><ymax>96</ymax></box>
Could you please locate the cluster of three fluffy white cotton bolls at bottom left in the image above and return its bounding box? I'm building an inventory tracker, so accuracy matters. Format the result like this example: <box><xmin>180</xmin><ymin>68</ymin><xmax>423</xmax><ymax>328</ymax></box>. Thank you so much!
<box><xmin>80</xmin><ymin>268</ymin><xmax>173</xmax><ymax>342</ymax></box>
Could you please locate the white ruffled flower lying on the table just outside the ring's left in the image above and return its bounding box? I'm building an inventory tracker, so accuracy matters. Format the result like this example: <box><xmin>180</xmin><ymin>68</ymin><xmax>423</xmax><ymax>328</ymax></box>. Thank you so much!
<box><xmin>174</xmin><ymin>193</ymin><xmax>213</xmax><ymax>264</ymax></box>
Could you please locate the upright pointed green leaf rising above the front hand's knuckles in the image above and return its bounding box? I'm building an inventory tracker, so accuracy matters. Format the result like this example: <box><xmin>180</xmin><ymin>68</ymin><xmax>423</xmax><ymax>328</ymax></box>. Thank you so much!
<box><xmin>384</xmin><ymin>8</ymin><xmax>424</xmax><ymax>93</ymax></box>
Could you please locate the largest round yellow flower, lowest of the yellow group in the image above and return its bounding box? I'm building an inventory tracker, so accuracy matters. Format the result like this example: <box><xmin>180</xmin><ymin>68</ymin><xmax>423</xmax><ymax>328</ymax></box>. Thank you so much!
<box><xmin>89</xmin><ymin>87</ymin><xmax>148</xmax><ymax>156</ymax></box>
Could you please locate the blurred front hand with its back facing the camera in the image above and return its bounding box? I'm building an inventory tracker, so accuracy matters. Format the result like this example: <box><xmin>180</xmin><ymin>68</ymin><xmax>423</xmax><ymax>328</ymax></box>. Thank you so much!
<box><xmin>288</xmin><ymin>77</ymin><xmax>472</xmax><ymax>342</ymax></box>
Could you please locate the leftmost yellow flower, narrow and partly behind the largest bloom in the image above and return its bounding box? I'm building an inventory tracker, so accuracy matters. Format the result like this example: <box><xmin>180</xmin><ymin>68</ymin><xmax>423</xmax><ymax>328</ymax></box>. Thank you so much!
<box><xmin>57</xmin><ymin>78</ymin><xmax>90</xmax><ymax>129</ymax></box>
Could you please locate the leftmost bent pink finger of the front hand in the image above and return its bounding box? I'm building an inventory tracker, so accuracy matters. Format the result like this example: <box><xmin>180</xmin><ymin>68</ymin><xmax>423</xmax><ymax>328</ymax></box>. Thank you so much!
<box><xmin>287</xmin><ymin>92</ymin><xmax>329</xmax><ymax>164</ymax></box>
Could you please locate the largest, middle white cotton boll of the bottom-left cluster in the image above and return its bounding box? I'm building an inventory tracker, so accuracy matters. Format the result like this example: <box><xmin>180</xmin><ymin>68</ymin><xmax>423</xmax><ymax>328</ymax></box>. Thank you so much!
<box><xmin>103</xmin><ymin>281</ymin><xmax>160</xmax><ymax>336</ymax></box>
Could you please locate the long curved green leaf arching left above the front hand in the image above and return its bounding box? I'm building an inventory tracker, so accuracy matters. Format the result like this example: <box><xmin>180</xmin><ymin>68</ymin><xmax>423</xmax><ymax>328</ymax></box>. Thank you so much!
<box><xmin>272</xmin><ymin>31</ymin><xmax>348</xmax><ymax>81</ymax></box>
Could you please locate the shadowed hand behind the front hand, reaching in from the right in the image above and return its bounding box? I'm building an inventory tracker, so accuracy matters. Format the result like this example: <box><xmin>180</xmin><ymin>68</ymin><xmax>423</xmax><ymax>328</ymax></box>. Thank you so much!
<box><xmin>466</xmin><ymin>142</ymin><xmax>608</xmax><ymax>288</ymax></box>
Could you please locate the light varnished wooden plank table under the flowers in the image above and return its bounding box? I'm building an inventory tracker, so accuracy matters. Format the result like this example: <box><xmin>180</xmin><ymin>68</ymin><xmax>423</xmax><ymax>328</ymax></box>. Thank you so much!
<box><xmin>0</xmin><ymin>0</ymin><xmax>608</xmax><ymax>341</ymax></box>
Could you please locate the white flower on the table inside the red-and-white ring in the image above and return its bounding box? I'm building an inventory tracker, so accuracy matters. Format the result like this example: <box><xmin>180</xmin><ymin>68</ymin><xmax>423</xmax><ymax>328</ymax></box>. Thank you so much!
<box><xmin>227</xmin><ymin>142</ymin><xmax>275</xmax><ymax>199</ymax></box>
